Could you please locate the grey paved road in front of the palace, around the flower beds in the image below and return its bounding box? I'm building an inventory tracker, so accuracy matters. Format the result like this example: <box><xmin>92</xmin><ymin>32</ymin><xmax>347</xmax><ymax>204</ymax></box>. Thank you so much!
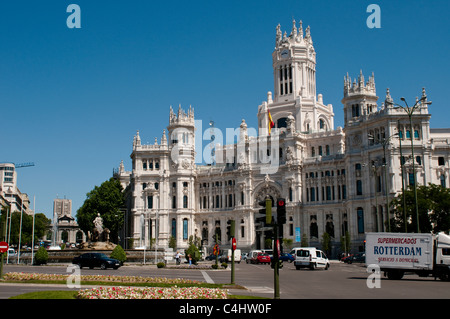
<box><xmin>0</xmin><ymin>262</ymin><xmax>450</xmax><ymax>299</ymax></box>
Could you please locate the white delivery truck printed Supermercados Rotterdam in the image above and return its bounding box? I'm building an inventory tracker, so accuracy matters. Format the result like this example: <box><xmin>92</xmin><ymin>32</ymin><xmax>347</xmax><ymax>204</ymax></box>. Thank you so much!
<box><xmin>366</xmin><ymin>233</ymin><xmax>450</xmax><ymax>280</ymax></box>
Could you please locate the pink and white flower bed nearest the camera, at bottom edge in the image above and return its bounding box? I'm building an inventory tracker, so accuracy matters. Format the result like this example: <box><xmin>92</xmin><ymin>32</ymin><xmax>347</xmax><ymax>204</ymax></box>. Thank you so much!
<box><xmin>77</xmin><ymin>286</ymin><xmax>228</xmax><ymax>299</ymax></box>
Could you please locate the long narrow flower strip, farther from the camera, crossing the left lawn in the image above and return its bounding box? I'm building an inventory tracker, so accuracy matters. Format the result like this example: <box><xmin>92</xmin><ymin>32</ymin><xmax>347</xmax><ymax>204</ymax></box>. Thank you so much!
<box><xmin>3</xmin><ymin>272</ymin><xmax>201</xmax><ymax>285</ymax></box>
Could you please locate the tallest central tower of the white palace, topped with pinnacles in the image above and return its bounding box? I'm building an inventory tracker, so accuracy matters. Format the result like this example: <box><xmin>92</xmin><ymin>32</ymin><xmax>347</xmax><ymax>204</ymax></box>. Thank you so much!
<box><xmin>258</xmin><ymin>20</ymin><xmax>334</xmax><ymax>135</ymax></box>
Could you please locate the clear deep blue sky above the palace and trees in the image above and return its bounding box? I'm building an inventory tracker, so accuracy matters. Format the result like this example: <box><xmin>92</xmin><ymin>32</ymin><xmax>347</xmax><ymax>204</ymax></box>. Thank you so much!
<box><xmin>0</xmin><ymin>0</ymin><xmax>450</xmax><ymax>217</ymax></box>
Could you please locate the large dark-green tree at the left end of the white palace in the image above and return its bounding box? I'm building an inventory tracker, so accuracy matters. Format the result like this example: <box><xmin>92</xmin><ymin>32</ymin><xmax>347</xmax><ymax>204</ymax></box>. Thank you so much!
<box><xmin>76</xmin><ymin>178</ymin><xmax>125</xmax><ymax>243</ymax></box>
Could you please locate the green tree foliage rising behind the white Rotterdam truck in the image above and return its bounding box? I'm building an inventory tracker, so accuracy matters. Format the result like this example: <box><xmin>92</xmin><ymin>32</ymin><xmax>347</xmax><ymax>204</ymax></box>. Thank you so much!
<box><xmin>391</xmin><ymin>184</ymin><xmax>450</xmax><ymax>233</ymax></box>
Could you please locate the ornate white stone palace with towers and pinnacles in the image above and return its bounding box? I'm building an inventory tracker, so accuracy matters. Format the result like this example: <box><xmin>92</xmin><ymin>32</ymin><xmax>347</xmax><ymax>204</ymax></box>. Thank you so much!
<box><xmin>117</xmin><ymin>21</ymin><xmax>450</xmax><ymax>254</ymax></box>
